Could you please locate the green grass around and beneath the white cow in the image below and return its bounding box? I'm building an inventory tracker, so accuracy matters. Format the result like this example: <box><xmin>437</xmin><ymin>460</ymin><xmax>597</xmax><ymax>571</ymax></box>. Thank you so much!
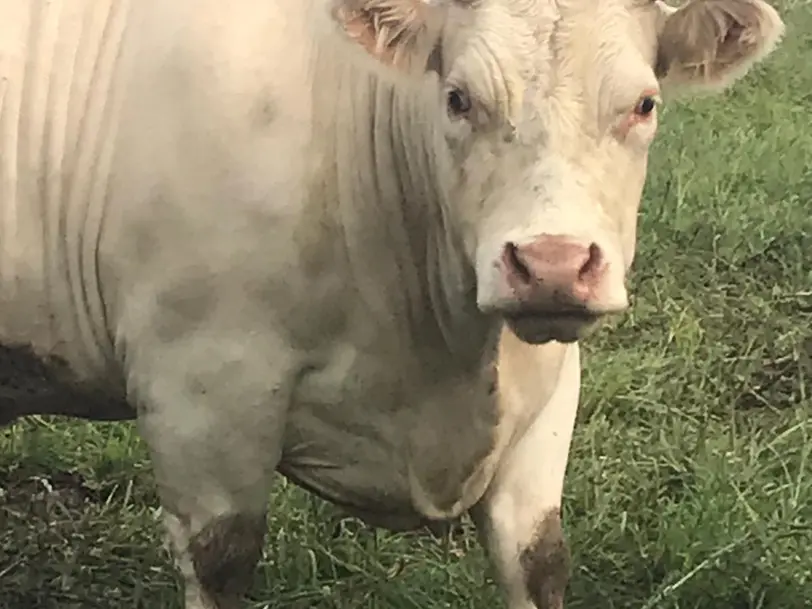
<box><xmin>0</xmin><ymin>0</ymin><xmax>812</xmax><ymax>609</ymax></box>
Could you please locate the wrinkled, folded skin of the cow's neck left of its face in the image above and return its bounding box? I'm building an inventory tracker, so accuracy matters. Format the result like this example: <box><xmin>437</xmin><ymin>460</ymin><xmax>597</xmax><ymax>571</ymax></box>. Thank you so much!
<box><xmin>324</xmin><ymin>51</ymin><xmax>496</xmax><ymax>364</ymax></box>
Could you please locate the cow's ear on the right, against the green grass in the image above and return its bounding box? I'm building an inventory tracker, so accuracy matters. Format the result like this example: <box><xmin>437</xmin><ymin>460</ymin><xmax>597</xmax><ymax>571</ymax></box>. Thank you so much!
<box><xmin>656</xmin><ymin>0</ymin><xmax>784</xmax><ymax>89</ymax></box>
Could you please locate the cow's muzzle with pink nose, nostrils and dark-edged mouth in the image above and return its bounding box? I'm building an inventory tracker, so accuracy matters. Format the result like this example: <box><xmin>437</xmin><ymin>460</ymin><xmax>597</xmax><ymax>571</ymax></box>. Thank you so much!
<box><xmin>488</xmin><ymin>234</ymin><xmax>628</xmax><ymax>343</ymax></box>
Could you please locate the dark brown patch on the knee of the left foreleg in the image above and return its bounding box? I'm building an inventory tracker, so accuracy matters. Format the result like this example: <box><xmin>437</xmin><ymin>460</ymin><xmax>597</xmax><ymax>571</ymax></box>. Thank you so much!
<box><xmin>189</xmin><ymin>514</ymin><xmax>265</xmax><ymax>609</ymax></box>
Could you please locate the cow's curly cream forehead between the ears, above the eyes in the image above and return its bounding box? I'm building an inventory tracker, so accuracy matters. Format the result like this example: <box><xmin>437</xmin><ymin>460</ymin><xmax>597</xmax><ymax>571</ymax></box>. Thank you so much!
<box><xmin>449</xmin><ymin>0</ymin><xmax>663</xmax><ymax>119</ymax></box>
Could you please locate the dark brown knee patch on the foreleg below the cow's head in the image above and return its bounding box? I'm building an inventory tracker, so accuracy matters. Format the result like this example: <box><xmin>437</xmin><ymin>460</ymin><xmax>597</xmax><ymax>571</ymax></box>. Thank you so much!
<box><xmin>521</xmin><ymin>509</ymin><xmax>570</xmax><ymax>609</ymax></box>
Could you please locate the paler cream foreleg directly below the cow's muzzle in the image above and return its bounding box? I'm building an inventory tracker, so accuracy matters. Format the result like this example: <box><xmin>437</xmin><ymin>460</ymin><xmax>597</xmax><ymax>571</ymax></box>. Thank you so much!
<box><xmin>471</xmin><ymin>344</ymin><xmax>580</xmax><ymax>609</ymax></box>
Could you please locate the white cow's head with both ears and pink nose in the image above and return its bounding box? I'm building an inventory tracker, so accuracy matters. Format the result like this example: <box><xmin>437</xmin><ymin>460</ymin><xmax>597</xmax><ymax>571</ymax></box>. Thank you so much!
<box><xmin>338</xmin><ymin>0</ymin><xmax>783</xmax><ymax>343</ymax></box>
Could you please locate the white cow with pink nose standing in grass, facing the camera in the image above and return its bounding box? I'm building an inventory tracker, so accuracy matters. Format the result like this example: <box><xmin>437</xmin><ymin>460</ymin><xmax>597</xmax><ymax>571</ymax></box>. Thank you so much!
<box><xmin>0</xmin><ymin>0</ymin><xmax>783</xmax><ymax>609</ymax></box>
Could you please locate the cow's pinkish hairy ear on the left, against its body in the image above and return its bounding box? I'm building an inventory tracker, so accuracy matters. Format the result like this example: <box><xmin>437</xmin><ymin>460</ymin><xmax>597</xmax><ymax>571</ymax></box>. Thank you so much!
<box><xmin>333</xmin><ymin>0</ymin><xmax>442</xmax><ymax>71</ymax></box>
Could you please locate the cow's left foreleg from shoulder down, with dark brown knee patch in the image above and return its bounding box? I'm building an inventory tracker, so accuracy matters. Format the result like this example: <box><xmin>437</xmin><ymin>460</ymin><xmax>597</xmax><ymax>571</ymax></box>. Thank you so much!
<box><xmin>128</xmin><ymin>339</ymin><xmax>286</xmax><ymax>609</ymax></box>
